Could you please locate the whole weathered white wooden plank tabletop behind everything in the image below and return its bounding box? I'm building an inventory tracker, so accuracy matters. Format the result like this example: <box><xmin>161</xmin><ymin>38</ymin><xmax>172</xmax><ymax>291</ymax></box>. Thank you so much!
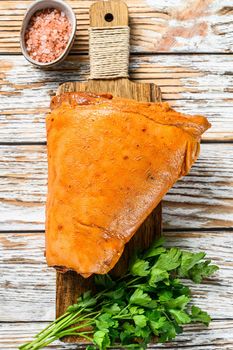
<box><xmin>0</xmin><ymin>0</ymin><xmax>233</xmax><ymax>350</ymax></box>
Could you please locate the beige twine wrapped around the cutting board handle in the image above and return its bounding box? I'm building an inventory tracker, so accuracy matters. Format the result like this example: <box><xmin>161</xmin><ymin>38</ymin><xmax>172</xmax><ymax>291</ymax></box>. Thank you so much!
<box><xmin>89</xmin><ymin>26</ymin><xmax>130</xmax><ymax>79</ymax></box>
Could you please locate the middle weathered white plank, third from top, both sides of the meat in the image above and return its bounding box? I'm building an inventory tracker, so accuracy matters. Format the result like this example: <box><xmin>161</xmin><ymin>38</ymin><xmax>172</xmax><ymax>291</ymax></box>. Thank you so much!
<box><xmin>0</xmin><ymin>144</ymin><xmax>233</xmax><ymax>230</ymax></box>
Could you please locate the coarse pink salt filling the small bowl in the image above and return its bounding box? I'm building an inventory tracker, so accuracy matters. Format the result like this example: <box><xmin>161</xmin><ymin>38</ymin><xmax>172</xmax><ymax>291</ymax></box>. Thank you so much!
<box><xmin>25</xmin><ymin>8</ymin><xmax>72</xmax><ymax>63</ymax></box>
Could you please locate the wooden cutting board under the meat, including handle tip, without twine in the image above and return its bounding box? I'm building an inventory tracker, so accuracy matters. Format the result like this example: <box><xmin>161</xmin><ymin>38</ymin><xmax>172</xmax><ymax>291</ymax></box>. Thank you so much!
<box><xmin>56</xmin><ymin>0</ymin><xmax>162</xmax><ymax>342</ymax></box>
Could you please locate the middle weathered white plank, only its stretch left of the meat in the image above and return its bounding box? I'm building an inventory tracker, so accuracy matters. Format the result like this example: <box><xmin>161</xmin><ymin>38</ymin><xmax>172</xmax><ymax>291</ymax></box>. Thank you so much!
<box><xmin>0</xmin><ymin>146</ymin><xmax>47</xmax><ymax>230</ymax></box>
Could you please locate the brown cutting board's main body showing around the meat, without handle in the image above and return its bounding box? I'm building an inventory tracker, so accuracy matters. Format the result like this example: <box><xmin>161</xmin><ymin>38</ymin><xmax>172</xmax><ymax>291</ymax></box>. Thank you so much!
<box><xmin>56</xmin><ymin>78</ymin><xmax>162</xmax><ymax>343</ymax></box>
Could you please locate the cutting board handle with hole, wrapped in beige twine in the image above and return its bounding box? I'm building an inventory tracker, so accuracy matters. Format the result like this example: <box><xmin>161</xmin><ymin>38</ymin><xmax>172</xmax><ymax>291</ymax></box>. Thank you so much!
<box><xmin>89</xmin><ymin>0</ymin><xmax>130</xmax><ymax>79</ymax></box>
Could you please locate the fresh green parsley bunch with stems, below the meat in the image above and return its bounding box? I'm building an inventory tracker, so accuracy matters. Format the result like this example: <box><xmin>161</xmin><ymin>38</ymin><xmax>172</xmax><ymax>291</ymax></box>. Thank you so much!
<box><xmin>20</xmin><ymin>239</ymin><xmax>218</xmax><ymax>350</ymax></box>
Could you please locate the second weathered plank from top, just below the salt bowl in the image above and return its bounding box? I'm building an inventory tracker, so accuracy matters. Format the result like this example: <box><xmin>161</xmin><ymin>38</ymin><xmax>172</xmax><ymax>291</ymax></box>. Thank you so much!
<box><xmin>0</xmin><ymin>55</ymin><xmax>233</xmax><ymax>142</ymax></box>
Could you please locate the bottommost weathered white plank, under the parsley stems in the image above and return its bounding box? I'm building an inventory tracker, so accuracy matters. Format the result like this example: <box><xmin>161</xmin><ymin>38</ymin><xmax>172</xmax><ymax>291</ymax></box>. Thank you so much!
<box><xmin>0</xmin><ymin>320</ymin><xmax>233</xmax><ymax>350</ymax></box>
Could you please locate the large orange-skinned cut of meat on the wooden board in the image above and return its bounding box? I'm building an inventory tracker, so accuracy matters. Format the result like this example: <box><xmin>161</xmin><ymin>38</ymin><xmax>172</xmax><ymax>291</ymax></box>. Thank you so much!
<box><xmin>46</xmin><ymin>92</ymin><xmax>210</xmax><ymax>277</ymax></box>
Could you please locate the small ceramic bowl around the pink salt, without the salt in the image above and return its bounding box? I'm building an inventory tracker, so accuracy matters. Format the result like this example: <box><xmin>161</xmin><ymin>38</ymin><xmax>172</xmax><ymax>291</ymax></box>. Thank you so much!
<box><xmin>20</xmin><ymin>0</ymin><xmax>76</xmax><ymax>68</ymax></box>
